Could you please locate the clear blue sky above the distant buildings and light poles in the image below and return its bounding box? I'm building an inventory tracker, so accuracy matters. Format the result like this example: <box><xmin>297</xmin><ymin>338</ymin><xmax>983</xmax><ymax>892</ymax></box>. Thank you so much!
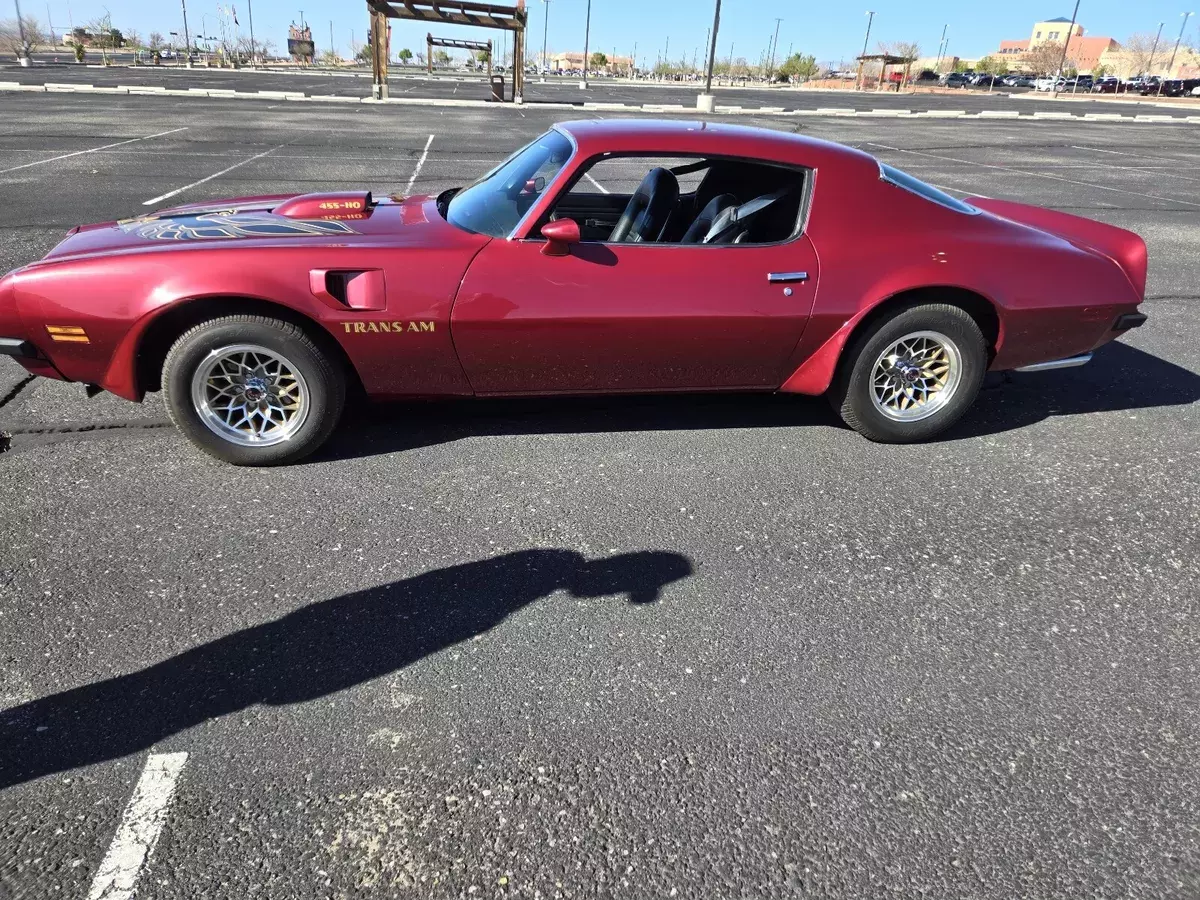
<box><xmin>21</xmin><ymin>0</ymin><xmax>1200</xmax><ymax>66</ymax></box>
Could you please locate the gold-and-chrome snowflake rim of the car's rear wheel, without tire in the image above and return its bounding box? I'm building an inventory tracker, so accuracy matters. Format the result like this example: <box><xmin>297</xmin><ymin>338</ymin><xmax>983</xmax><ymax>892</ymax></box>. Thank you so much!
<box><xmin>871</xmin><ymin>331</ymin><xmax>962</xmax><ymax>422</ymax></box>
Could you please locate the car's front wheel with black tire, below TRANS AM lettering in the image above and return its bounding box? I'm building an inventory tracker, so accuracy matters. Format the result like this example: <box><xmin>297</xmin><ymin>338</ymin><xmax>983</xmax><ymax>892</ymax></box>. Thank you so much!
<box><xmin>162</xmin><ymin>316</ymin><xmax>346</xmax><ymax>466</ymax></box>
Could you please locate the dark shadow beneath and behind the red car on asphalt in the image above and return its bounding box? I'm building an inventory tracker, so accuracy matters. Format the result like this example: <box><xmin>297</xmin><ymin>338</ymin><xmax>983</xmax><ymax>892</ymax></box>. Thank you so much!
<box><xmin>311</xmin><ymin>342</ymin><xmax>1200</xmax><ymax>462</ymax></box>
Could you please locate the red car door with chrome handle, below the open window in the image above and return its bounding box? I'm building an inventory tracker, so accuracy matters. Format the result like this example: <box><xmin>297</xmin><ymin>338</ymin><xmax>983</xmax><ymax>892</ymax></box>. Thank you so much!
<box><xmin>451</xmin><ymin>234</ymin><xmax>818</xmax><ymax>394</ymax></box>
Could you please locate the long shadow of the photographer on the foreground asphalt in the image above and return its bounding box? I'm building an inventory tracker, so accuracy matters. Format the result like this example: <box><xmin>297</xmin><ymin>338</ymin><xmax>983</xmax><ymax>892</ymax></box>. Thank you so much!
<box><xmin>0</xmin><ymin>550</ymin><xmax>692</xmax><ymax>790</ymax></box>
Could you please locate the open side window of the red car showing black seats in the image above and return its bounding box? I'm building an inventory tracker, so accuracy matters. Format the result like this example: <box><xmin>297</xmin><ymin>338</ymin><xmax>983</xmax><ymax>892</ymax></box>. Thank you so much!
<box><xmin>550</xmin><ymin>155</ymin><xmax>806</xmax><ymax>245</ymax></box>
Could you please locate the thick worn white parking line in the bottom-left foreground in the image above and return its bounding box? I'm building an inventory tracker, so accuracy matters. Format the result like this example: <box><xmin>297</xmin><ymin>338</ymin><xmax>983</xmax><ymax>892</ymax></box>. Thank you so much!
<box><xmin>88</xmin><ymin>754</ymin><xmax>187</xmax><ymax>900</ymax></box>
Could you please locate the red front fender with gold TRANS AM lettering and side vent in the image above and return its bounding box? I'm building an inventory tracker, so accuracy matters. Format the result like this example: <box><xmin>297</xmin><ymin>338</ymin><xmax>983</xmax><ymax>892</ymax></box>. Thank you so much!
<box><xmin>23</xmin><ymin>242</ymin><xmax>475</xmax><ymax>400</ymax></box>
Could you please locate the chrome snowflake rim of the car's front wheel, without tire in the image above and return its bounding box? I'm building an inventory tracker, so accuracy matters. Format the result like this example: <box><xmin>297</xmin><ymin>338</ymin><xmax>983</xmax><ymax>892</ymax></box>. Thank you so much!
<box><xmin>192</xmin><ymin>343</ymin><xmax>311</xmax><ymax>446</ymax></box>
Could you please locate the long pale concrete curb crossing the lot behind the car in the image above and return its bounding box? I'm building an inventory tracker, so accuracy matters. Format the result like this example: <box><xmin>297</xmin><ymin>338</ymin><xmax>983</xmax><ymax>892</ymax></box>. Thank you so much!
<box><xmin>0</xmin><ymin>82</ymin><xmax>1200</xmax><ymax>125</ymax></box>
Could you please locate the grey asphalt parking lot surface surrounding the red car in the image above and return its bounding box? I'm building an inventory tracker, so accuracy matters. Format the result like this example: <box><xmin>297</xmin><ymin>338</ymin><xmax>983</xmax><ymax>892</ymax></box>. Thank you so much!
<box><xmin>0</xmin><ymin>94</ymin><xmax>1200</xmax><ymax>900</ymax></box>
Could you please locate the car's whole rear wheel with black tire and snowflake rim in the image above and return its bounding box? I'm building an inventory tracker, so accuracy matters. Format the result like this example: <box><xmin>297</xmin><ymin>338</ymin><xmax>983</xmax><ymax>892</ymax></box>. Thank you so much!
<box><xmin>829</xmin><ymin>304</ymin><xmax>988</xmax><ymax>444</ymax></box>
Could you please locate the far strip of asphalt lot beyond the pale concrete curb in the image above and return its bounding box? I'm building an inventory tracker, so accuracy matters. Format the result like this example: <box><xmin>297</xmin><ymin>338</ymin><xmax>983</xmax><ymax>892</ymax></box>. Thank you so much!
<box><xmin>0</xmin><ymin>65</ymin><xmax>1200</xmax><ymax>118</ymax></box>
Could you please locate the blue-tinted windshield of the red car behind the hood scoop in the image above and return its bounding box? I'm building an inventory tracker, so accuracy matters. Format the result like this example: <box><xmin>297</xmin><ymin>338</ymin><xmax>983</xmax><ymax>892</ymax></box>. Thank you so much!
<box><xmin>445</xmin><ymin>131</ymin><xmax>571</xmax><ymax>238</ymax></box>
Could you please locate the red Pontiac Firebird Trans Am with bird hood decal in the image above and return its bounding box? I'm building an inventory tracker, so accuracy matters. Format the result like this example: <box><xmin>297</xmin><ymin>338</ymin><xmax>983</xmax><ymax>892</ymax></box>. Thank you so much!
<box><xmin>0</xmin><ymin>120</ymin><xmax>1146</xmax><ymax>466</ymax></box>
